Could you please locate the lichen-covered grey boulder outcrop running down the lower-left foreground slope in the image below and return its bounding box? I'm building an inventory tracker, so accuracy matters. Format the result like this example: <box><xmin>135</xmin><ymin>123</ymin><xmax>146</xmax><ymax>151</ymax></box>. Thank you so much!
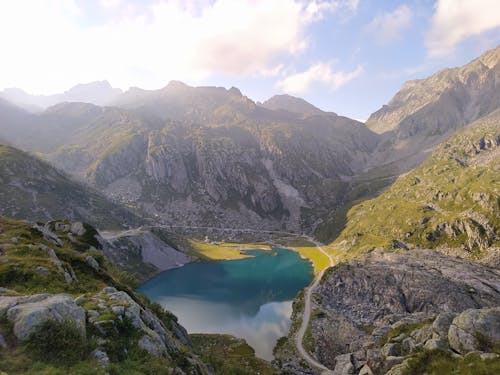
<box><xmin>0</xmin><ymin>287</ymin><xmax>210</xmax><ymax>375</ymax></box>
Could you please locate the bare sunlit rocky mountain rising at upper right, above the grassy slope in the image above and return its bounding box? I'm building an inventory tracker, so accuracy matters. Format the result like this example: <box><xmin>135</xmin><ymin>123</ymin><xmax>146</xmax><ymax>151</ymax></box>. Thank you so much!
<box><xmin>366</xmin><ymin>46</ymin><xmax>500</xmax><ymax>172</ymax></box>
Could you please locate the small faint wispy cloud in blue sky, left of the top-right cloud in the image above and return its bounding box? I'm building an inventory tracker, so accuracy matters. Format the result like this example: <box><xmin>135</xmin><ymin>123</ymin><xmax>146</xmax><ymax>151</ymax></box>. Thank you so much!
<box><xmin>367</xmin><ymin>5</ymin><xmax>413</xmax><ymax>44</ymax></box>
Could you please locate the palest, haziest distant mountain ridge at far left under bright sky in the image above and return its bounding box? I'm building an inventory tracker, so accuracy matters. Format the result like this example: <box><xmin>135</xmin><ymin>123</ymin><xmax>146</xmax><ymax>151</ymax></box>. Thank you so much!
<box><xmin>0</xmin><ymin>81</ymin><xmax>122</xmax><ymax>112</ymax></box>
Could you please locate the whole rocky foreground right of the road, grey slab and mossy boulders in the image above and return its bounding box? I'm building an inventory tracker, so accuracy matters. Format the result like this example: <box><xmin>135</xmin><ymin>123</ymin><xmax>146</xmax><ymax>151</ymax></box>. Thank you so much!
<box><xmin>277</xmin><ymin>250</ymin><xmax>500</xmax><ymax>375</ymax></box>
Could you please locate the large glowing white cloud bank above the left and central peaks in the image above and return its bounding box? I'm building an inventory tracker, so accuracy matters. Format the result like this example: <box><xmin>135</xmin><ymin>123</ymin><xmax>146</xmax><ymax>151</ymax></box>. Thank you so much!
<box><xmin>0</xmin><ymin>0</ymin><xmax>357</xmax><ymax>93</ymax></box>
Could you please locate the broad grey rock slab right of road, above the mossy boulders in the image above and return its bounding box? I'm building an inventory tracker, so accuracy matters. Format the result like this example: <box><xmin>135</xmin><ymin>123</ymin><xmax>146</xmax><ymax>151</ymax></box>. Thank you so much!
<box><xmin>317</xmin><ymin>250</ymin><xmax>500</xmax><ymax>334</ymax></box>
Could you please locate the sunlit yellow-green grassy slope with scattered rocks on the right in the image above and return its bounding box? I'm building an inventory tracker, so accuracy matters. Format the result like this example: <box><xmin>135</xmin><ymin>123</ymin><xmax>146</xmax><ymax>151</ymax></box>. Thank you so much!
<box><xmin>330</xmin><ymin>111</ymin><xmax>500</xmax><ymax>257</ymax></box>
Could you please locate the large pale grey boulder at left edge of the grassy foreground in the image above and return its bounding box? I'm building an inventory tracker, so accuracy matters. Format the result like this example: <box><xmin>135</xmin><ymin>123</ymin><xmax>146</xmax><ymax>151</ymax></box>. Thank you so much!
<box><xmin>0</xmin><ymin>294</ymin><xmax>86</xmax><ymax>341</ymax></box>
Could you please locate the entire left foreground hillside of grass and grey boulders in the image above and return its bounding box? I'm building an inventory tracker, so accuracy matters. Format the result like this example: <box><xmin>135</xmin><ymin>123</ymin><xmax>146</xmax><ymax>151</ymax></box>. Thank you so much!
<box><xmin>0</xmin><ymin>218</ymin><xmax>213</xmax><ymax>375</ymax></box>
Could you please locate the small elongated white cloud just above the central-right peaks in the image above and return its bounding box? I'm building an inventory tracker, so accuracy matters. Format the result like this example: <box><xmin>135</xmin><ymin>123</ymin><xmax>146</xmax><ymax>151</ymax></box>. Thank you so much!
<box><xmin>278</xmin><ymin>63</ymin><xmax>363</xmax><ymax>94</ymax></box>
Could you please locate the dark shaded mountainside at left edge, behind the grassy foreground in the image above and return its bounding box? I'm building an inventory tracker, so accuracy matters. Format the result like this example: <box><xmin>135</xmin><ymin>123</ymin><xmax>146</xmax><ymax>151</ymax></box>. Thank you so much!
<box><xmin>0</xmin><ymin>145</ymin><xmax>143</xmax><ymax>228</ymax></box>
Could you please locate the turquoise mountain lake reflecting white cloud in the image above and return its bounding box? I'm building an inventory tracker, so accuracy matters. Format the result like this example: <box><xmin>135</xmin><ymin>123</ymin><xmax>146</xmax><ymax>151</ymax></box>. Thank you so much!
<box><xmin>139</xmin><ymin>249</ymin><xmax>313</xmax><ymax>360</ymax></box>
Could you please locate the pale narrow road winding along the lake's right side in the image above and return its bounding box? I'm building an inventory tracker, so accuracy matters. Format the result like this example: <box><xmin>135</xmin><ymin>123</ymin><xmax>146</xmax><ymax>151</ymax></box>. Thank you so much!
<box><xmin>295</xmin><ymin>236</ymin><xmax>334</xmax><ymax>371</ymax></box>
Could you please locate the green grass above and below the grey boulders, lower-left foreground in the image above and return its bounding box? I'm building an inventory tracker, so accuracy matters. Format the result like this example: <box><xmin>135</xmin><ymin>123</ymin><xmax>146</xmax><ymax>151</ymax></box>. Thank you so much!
<box><xmin>0</xmin><ymin>218</ymin><xmax>199</xmax><ymax>375</ymax></box>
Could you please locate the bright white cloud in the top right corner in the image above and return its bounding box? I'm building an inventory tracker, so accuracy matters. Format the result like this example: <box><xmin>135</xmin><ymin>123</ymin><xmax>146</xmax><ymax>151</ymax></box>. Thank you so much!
<box><xmin>426</xmin><ymin>0</ymin><xmax>500</xmax><ymax>57</ymax></box>
